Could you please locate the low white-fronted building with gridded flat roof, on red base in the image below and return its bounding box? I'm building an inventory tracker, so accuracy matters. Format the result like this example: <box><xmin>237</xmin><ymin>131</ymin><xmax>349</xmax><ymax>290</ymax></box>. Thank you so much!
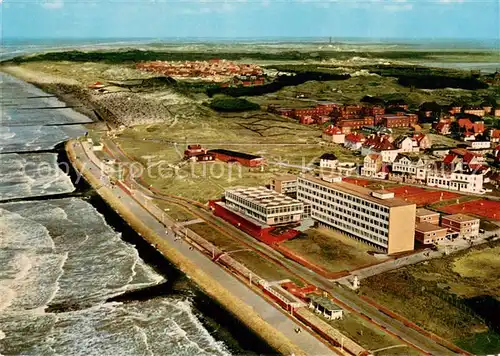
<box><xmin>224</xmin><ymin>187</ymin><xmax>304</xmax><ymax>225</ymax></box>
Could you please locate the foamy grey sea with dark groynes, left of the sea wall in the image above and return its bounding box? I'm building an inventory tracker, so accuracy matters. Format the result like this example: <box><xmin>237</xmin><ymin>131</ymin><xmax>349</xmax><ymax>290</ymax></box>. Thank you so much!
<box><xmin>0</xmin><ymin>69</ymin><xmax>254</xmax><ymax>355</ymax></box>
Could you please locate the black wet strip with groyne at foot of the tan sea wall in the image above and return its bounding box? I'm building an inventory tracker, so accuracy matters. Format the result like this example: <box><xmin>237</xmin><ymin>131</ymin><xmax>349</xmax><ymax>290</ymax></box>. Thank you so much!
<box><xmin>55</xmin><ymin>143</ymin><xmax>275</xmax><ymax>354</ymax></box>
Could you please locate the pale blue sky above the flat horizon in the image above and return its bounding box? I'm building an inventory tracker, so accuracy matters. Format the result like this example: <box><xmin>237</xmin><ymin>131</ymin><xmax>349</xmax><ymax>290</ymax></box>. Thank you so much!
<box><xmin>0</xmin><ymin>0</ymin><xmax>500</xmax><ymax>39</ymax></box>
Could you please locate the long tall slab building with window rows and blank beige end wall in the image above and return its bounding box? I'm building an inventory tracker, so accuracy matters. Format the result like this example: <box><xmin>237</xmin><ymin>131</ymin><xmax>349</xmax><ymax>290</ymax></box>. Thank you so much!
<box><xmin>297</xmin><ymin>175</ymin><xmax>416</xmax><ymax>254</ymax></box>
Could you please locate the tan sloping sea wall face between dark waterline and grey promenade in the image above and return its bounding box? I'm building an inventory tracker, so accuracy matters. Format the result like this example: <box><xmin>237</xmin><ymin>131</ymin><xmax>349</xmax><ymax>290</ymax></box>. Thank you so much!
<box><xmin>66</xmin><ymin>142</ymin><xmax>305</xmax><ymax>355</ymax></box>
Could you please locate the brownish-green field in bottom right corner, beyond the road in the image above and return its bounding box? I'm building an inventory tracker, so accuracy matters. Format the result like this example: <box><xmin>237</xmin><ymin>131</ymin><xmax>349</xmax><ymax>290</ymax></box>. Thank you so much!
<box><xmin>361</xmin><ymin>243</ymin><xmax>500</xmax><ymax>354</ymax></box>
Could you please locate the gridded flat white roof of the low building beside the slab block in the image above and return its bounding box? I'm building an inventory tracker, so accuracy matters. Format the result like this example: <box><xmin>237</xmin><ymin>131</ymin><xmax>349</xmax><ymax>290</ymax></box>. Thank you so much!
<box><xmin>226</xmin><ymin>187</ymin><xmax>302</xmax><ymax>208</ymax></box>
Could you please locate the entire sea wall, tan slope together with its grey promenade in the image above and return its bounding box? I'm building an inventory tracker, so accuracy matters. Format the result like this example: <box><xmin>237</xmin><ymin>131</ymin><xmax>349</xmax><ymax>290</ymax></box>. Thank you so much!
<box><xmin>66</xmin><ymin>140</ymin><xmax>334</xmax><ymax>355</ymax></box>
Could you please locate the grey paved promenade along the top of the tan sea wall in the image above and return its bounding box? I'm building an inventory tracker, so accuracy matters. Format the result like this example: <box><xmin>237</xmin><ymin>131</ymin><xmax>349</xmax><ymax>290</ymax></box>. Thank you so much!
<box><xmin>73</xmin><ymin>143</ymin><xmax>334</xmax><ymax>355</ymax></box>
